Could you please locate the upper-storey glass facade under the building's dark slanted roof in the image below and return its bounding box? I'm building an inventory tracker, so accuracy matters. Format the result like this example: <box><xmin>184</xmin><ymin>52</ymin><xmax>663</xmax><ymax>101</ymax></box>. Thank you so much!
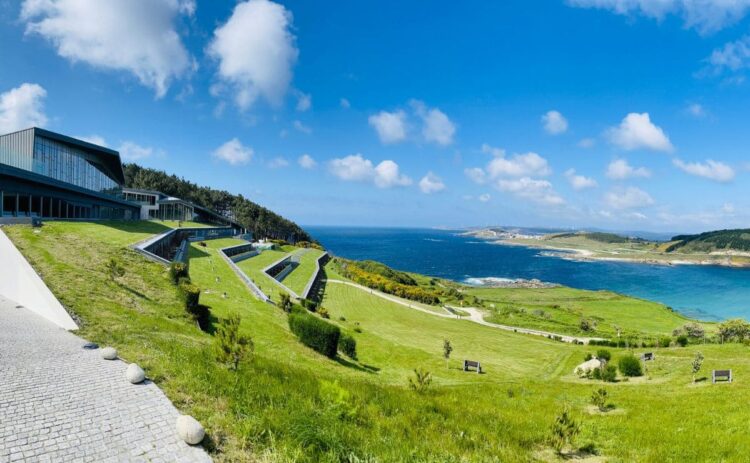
<box><xmin>31</xmin><ymin>137</ymin><xmax>120</xmax><ymax>195</ymax></box>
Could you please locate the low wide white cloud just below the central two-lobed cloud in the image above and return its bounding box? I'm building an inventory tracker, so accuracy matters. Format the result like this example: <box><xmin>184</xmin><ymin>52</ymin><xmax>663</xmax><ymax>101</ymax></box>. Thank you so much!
<box><xmin>328</xmin><ymin>154</ymin><xmax>412</xmax><ymax>188</ymax></box>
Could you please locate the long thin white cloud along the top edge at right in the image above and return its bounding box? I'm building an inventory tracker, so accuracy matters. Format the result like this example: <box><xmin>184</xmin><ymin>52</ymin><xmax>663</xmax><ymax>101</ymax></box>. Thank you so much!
<box><xmin>568</xmin><ymin>0</ymin><xmax>750</xmax><ymax>34</ymax></box>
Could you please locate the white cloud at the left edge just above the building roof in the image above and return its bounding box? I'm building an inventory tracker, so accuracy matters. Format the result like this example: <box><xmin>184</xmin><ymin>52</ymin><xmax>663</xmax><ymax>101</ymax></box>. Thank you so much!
<box><xmin>0</xmin><ymin>83</ymin><xmax>47</xmax><ymax>134</ymax></box>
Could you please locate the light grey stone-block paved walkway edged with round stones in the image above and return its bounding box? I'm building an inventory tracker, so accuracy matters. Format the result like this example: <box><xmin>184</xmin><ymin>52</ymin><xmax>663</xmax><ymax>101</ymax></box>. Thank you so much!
<box><xmin>0</xmin><ymin>296</ymin><xmax>211</xmax><ymax>463</ymax></box>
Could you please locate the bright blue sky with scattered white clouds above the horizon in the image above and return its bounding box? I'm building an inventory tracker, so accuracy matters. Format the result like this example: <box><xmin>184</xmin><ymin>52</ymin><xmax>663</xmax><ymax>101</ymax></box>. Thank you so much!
<box><xmin>0</xmin><ymin>0</ymin><xmax>750</xmax><ymax>231</ymax></box>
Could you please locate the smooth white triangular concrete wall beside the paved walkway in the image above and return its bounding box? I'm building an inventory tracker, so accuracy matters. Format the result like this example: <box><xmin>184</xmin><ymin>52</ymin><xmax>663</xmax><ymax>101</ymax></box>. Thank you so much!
<box><xmin>0</xmin><ymin>230</ymin><xmax>78</xmax><ymax>330</ymax></box>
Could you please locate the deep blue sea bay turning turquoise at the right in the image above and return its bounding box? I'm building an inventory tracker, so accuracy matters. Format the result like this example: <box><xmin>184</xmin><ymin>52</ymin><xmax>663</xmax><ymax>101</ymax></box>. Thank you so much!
<box><xmin>305</xmin><ymin>226</ymin><xmax>750</xmax><ymax>320</ymax></box>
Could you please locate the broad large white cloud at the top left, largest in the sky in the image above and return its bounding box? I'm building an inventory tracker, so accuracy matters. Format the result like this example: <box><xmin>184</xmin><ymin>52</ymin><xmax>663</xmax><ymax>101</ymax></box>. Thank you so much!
<box><xmin>21</xmin><ymin>0</ymin><xmax>195</xmax><ymax>97</ymax></box>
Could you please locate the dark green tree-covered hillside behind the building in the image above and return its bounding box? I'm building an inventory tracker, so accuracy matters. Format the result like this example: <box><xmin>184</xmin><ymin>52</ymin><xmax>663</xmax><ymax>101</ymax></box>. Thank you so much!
<box><xmin>123</xmin><ymin>164</ymin><xmax>311</xmax><ymax>242</ymax></box>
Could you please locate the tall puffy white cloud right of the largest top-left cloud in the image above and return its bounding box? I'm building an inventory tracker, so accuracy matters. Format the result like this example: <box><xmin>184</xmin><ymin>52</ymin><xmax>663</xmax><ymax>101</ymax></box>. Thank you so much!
<box><xmin>207</xmin><ymin>0</ymin><xmax>299</xmax><ymax>110</ymax></box>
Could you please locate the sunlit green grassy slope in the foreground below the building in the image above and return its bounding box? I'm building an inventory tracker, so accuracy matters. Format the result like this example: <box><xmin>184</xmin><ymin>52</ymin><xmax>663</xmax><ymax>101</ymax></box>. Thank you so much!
<box><xmin>6</xmin><ymin>223</ymin><xmax>750</xmax><ymax>462</ymax></box>
